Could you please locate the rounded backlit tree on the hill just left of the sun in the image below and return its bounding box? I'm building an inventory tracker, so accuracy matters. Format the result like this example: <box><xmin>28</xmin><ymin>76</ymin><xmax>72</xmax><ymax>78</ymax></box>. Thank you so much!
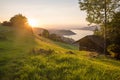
<box><xmin>10</xmin><ymin>14</ymin><xmax>28</xmax><ymax>27</ymax></box>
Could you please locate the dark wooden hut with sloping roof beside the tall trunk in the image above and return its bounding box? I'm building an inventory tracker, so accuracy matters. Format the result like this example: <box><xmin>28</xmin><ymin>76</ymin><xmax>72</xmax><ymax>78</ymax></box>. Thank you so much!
<box><xmin>75</xmin><ymin>35</ymin><xmax>104</xmax><ymax>53</ymax></box>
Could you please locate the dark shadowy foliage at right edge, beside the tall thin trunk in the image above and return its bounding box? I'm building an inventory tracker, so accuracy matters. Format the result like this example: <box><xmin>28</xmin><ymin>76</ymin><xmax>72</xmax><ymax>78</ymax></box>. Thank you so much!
<box><xmin>107</xmin><ymin>12</ymin><xmax>120</xmax><ymax>59</ymax></box>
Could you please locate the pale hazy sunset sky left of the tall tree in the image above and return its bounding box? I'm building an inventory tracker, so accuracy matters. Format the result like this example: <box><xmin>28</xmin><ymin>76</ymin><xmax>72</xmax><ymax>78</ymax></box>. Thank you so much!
<box><xmin>0</xmin><ymin>0</ymin><xmax>87</xmax><ymax>26</ymax></box>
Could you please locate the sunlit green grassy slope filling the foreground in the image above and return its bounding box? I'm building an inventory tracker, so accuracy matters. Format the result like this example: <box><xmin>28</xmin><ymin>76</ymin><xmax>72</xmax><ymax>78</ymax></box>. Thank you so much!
<box><xmin>0</xmin><ymin>26</ymin><xmax>120</xmax><ymax>80</ymax></box>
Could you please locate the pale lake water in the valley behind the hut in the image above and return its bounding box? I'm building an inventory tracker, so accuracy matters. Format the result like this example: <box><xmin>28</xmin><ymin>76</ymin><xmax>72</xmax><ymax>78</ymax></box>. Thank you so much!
<box><xmin>64</xmin><ymin>30</ymin><xmax>93</xmax><ymax>41</ymax></box>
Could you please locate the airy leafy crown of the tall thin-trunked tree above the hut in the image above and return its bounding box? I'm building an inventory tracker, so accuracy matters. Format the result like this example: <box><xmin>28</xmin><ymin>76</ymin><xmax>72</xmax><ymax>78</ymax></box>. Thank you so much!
<box><xmin>79</xmin><ymin>0</ymin><xmax>119</xmax><ymax>25</ymax></box>
